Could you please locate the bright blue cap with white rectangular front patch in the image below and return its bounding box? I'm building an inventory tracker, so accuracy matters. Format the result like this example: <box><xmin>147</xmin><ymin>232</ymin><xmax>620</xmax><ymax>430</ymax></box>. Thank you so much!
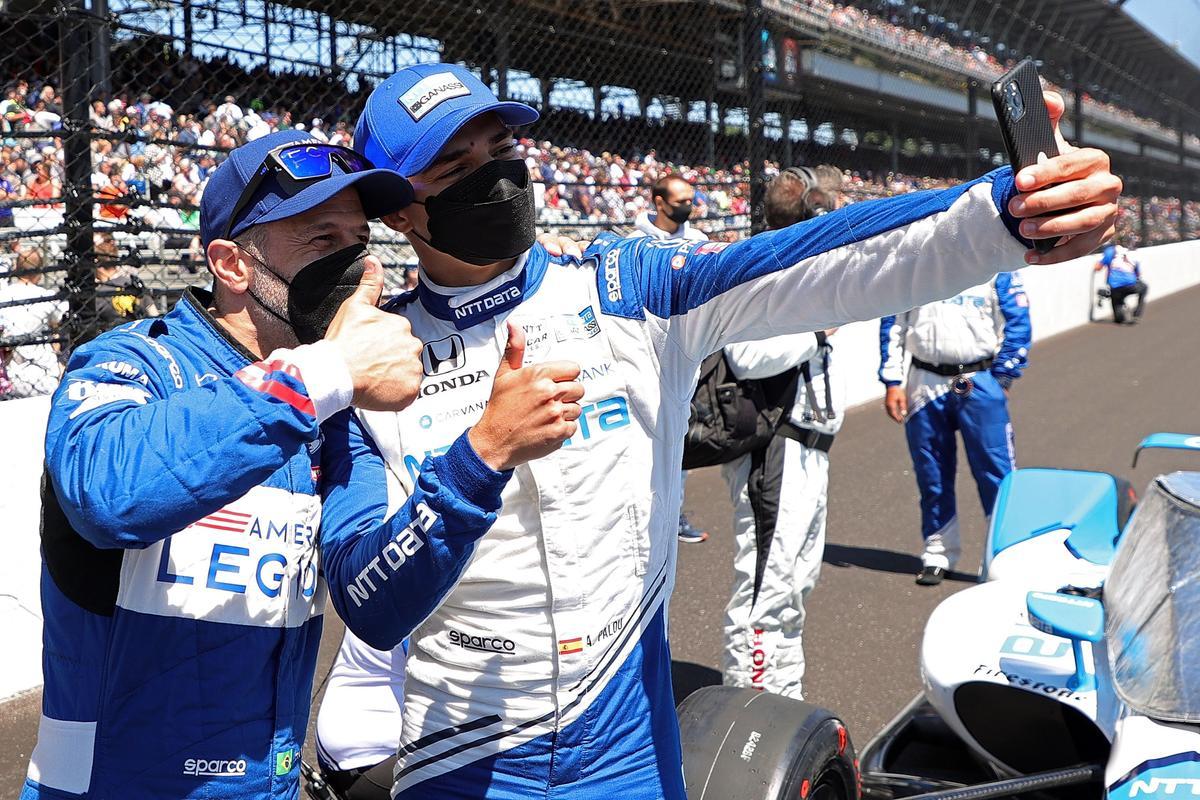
<box><xmin>354</xmin><ymin>64</ymin><xmax>538</xmax><ymax>176</ymax></box>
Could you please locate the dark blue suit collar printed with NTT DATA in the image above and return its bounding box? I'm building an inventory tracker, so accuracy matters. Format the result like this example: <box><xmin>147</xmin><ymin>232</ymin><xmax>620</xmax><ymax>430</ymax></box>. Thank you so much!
<box><xmin>416</xmin><ymin>243</ymin><xmax>550</xmax><ymax>331</ymax></box>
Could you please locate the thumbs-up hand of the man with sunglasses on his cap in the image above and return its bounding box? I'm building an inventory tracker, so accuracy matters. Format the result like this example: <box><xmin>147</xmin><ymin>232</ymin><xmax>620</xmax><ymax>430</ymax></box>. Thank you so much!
<box><xmin>325</xmin><ymin>255</ymin><xmax>422</xmax><ymax>411</ymax></box>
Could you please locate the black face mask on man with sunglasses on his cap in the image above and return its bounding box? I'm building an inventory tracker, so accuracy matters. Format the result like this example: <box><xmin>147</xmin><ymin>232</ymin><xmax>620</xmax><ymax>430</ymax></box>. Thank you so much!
<box><xmin>245</xmin><ymin>243</ymin><xmax>367</xmax><ymax>344</ymax></box>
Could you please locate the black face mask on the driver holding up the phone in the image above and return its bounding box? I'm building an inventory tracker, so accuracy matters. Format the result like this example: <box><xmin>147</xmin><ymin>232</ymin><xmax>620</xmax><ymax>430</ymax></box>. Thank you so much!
<box><xmin>413</xmin><ymin>160</ymin><xmax>538</xmax><ymax>266</ymax></box>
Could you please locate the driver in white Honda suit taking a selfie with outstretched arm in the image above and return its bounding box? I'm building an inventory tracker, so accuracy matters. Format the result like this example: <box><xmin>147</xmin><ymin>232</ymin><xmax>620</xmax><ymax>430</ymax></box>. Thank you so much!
<box><xmin>345</xmin><ymin>64</ymin><xmax>1121</xmax><ymax>800</ymax></box>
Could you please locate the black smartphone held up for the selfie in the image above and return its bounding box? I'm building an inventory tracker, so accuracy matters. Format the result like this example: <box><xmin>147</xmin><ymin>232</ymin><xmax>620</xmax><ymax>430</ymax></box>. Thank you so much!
<box><xmin>991</xmin><ymin>59</ymin><xmax>1058</xmax><ymax>253</ymax></box>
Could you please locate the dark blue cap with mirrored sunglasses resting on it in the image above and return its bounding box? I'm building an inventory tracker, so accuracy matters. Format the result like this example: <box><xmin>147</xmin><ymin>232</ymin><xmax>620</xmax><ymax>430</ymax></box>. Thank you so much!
<box><xmin>200</xmin><ymin>131</ymin><xmax>413</xmax><ymax>247</ymax></box>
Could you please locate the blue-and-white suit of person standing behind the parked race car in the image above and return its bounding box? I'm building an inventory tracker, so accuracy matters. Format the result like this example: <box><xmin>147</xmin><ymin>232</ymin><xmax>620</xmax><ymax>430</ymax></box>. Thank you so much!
<box><xmin>880</xmin><ymin>272</ymin><xmax>1031</xmax><ymax>570</ymax></box>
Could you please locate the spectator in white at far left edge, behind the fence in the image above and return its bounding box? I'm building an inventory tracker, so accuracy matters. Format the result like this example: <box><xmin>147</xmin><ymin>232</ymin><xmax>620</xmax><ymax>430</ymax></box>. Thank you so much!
<box><xmin>0</xmin><ymin>246</ymin><xmax>67</xmax><ymax>399</ymax></box>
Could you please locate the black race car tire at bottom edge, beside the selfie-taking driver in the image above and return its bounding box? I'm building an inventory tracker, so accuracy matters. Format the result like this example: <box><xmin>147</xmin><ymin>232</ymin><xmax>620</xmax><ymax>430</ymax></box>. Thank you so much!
<box><xmin>678</xmin><ymin>686</ymin><xmax>859</xmax><ymax>800</ymax></box>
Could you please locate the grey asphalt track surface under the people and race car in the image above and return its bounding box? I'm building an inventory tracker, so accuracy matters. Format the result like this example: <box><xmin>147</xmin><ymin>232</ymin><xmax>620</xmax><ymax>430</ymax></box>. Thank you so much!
<box><xmin>0</xmin><ymin>288</ymin><xmax>1200</xmax><ymax>798</ymax></box>
